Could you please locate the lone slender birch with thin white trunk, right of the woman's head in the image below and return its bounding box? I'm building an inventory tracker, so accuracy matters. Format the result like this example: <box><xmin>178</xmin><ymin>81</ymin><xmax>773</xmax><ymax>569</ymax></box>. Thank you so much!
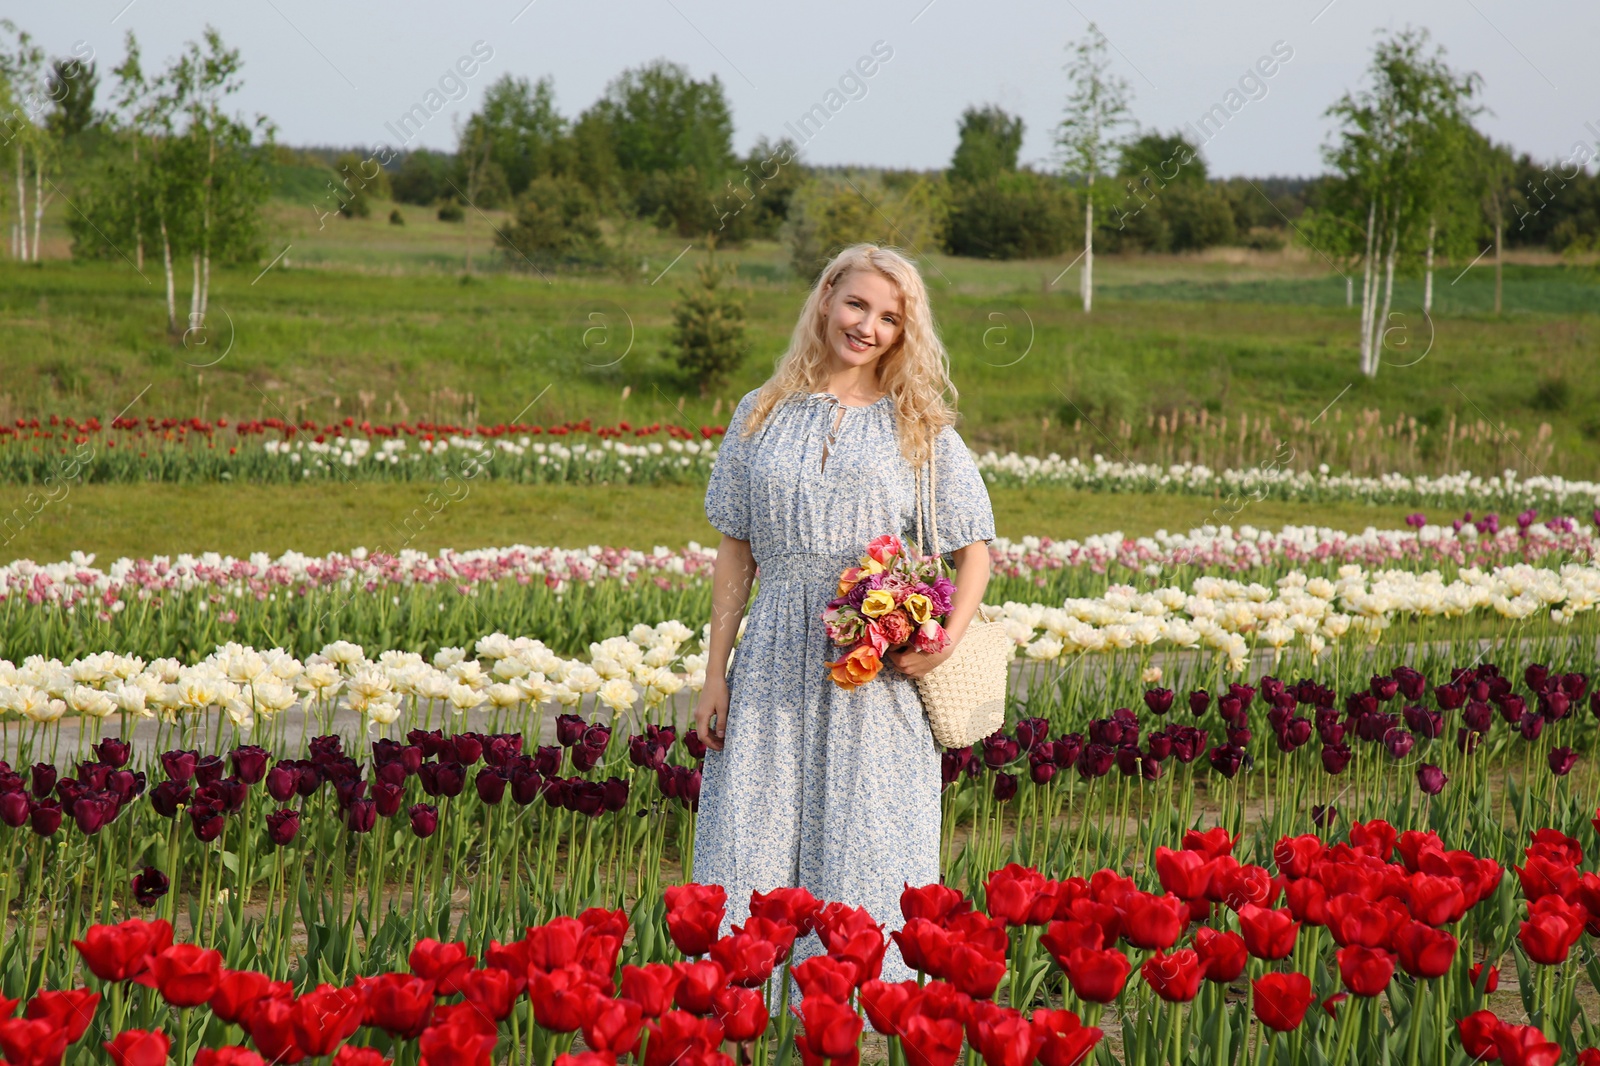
<box><xmin>1056</xmin><ymin>22</ymin><xmax>1138</xmax><ymax>312</ymax></box>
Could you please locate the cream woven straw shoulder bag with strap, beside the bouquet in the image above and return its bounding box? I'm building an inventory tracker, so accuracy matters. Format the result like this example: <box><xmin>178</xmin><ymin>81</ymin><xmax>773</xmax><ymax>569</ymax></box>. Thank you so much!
<box><xmin>914</xmin><ymin>425</ymin><xmax>1016</xmax><ymax>747</ymax></box>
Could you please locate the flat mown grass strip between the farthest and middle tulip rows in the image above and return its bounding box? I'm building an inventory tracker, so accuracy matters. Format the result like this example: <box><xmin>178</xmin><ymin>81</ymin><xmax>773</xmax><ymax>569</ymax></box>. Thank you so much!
<box><xmin>0</xmin><ymin>482</ymin><xmax>1405</xmax><ymax>563</ymax></box>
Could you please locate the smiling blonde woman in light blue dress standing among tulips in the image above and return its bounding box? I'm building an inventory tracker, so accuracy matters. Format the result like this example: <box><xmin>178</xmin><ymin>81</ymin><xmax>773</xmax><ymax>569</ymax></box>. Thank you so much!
<box><xmin>694</xmin><ymin>245</ymin><xmax>995</xmax><ymax>981</ymax></box>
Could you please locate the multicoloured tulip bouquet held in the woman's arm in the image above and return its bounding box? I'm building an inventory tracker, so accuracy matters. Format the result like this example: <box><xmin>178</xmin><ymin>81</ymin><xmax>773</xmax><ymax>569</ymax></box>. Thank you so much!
<box><xmin>822</xmin><ymin>535</ymin><xmax>955</xmax><ymax>688</ymax></box>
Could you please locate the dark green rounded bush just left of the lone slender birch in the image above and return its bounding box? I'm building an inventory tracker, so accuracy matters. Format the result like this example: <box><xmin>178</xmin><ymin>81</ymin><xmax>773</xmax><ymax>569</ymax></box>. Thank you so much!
<box><xmin>944</xmin><ymin>170</ymin><xmax>1083</xmax><ymax>259</ymax></box>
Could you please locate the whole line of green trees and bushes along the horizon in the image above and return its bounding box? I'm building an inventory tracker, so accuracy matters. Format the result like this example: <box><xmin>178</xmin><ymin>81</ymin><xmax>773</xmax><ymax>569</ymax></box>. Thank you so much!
<box><xmin>0</xmin><ymin>22</ymin><xmax>1600</xmax><ymax>373</ymax></box>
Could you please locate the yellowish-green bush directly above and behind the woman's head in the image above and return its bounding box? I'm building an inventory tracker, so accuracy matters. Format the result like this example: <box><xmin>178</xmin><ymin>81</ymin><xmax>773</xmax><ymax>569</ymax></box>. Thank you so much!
<box><xmin>784</xmin><ymin>174</ymin><xmax>949</xmax><ymax>282</ymax></box>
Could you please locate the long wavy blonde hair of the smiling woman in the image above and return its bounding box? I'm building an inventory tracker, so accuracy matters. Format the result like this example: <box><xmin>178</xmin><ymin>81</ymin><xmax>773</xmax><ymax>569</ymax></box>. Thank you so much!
<box><xmin>742</xmin><ymin>243</ymin><xmax>958</xmax><ymax>466</ymax></box>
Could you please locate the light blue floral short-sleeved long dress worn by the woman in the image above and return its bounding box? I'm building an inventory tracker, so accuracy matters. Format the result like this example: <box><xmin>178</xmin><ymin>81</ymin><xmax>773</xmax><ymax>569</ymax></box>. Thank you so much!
<box><xmin>694</xmin><ymin>382</ymin><xmax>995</xmax><ymax>981</ymax></box>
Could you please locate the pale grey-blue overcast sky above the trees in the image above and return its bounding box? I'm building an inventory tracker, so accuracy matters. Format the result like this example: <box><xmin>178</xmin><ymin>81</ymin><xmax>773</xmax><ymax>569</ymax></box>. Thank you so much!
<box><xmin>0</xmin><ymin>0</ymin><xmax>1600</xmax><ymax>174</ymax></box>
